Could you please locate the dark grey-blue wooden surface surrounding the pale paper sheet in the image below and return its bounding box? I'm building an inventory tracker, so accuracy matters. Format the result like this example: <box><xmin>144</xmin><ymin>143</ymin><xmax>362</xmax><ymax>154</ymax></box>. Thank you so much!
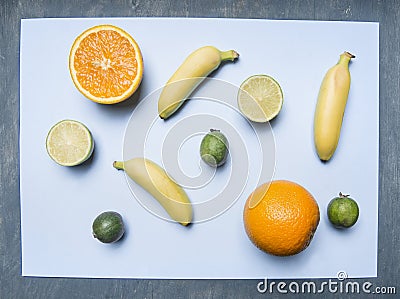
<box><xmin>0</xmin><ymin>0</ymin><xmax>400</xmax><ymax>299</ymax></box>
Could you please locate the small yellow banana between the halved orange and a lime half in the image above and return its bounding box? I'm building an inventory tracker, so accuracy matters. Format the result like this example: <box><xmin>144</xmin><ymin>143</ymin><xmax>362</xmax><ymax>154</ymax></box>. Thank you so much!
<box><xmin>158</xmin><ymin>46</ymin><xmax>239</xmax><ymax>119</ymax></box>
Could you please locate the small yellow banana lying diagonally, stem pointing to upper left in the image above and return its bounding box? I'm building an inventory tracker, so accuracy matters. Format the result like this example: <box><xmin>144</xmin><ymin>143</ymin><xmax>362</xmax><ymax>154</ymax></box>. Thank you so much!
<box><xmin>113</xmin><ymin>158</ymin><xmax>193</xmax><ymax>226</ymax></box>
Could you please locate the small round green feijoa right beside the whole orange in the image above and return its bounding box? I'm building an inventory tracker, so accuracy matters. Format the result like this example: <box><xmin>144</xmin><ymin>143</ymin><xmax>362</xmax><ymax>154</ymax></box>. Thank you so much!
<box><xmin>328</xmin><ymin>194</ymin><xmax>359</xmax><ymax>228</ymax></box>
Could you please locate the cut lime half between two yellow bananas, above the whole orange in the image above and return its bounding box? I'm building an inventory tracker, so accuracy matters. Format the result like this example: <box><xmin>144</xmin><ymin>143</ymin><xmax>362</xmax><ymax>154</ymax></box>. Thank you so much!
<box><xmin>238</xmin><ymin>75</ymin><xmax>283</xmax><ymax>123</ymax></box>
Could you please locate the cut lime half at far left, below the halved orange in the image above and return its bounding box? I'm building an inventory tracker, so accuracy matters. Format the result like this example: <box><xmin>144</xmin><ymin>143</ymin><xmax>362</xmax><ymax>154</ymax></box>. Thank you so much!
<box><xmin>46</xmin><ymin>120</ymin><xmax>94</xmax><ymax>166</ymax></box>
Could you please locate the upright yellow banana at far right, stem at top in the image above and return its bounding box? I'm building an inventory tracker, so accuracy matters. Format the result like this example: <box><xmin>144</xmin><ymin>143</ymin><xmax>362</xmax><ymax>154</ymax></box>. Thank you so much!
<box><xmin>314</xmin><ymin>52</ymin><xmax>355</xmax><ymax>161</ymax></box>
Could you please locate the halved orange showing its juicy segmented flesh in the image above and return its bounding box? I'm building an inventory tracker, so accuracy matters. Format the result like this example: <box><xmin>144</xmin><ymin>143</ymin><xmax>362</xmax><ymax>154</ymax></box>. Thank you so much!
<box><xmin>69</xmin><ymin>25</ymin><xmax>143</xmax><ymax>104</ymax></box>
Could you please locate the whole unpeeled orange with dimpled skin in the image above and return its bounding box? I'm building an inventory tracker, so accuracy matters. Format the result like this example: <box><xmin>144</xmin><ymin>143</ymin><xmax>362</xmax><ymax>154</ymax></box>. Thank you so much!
<box><xmin>243</xmin><ymin>180</ymin><xmax>320</xmax><ymax>256</ymax></box>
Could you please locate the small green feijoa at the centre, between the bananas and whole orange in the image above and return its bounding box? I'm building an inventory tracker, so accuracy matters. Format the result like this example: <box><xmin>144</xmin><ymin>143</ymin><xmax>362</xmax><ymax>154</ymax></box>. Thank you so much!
<box><xmin>200</xmin><ymin>129</ymin><xmax>229</xmax><ymax>167</ymax></box>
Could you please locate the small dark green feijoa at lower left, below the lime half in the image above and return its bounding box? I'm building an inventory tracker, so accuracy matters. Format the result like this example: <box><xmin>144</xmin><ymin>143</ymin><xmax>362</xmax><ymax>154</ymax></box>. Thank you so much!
<box><xmin>92</xmin><ymin>211</ymin><xmax>125</xmax><ymax>243</ymax></box>
